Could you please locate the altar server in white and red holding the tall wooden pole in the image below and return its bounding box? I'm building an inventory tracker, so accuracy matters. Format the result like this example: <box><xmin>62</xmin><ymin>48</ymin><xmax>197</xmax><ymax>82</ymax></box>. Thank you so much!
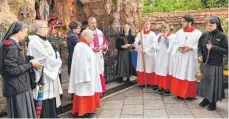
<box><xmin>134</xmin><ymin>20</ymin><xmax>157</xmax><ymax>87</ymax></box>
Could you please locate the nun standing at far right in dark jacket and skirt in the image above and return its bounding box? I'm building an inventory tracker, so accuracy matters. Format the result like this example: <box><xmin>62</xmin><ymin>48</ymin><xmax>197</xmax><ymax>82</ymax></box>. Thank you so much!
<box><xmin>198</xmin><ymin>16</ymin><xmax>228</xmax><ymax>111</ymax></box>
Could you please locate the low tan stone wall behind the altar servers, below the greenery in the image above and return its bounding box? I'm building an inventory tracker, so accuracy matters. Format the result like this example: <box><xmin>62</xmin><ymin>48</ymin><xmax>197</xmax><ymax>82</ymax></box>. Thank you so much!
<box><xmin>143</xmin><ymin>8</ymin><xmax>228</xmax><ymax>32</ymax></box>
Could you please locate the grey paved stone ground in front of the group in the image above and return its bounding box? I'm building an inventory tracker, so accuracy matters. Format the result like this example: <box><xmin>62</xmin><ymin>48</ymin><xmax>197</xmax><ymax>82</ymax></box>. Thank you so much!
<box><xmin>61</xmin><ymin>87</ymin><xmax>228</xmax><ymax>118</ymax></box>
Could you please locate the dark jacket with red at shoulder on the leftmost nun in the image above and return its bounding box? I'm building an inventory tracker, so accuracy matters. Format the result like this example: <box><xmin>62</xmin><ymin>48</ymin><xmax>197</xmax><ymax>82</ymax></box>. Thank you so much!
<box><xmin>3</xmin><ymin>39</ymin><xmax>32</xmax><ymax>97</ymax></box>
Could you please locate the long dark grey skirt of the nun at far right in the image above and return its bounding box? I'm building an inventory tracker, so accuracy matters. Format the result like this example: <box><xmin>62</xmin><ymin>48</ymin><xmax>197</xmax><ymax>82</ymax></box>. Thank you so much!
<box><xmin>198</xmin><ymin>64</ymin><xmax>225</xmax><ymax>102</ymax></box>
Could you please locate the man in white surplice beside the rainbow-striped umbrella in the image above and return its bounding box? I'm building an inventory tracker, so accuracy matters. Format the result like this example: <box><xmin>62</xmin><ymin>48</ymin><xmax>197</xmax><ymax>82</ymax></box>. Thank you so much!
<box><xmin>28</xmin><ymin>20</ymin><xmax>63</xmax><ymax>118</ymax></box>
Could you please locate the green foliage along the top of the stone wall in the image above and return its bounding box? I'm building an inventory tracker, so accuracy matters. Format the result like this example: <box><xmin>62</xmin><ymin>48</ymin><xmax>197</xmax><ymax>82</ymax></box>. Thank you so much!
<box><xmin>141</xmin><ymin>0</ymin><xmax>228</xmax><ymax>13</ymax></box>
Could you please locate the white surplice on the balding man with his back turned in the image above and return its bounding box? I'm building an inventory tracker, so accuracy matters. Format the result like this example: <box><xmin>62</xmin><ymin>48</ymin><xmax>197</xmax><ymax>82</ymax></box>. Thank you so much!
<box><xmin>68</xmin><ymin>42</ymin><xmax>102</xmax><ymax>96</ymax></box>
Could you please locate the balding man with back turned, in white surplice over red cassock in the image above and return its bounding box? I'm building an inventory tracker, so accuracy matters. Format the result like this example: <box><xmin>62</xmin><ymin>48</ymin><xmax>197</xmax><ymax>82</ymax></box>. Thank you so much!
<box><xmin>68</xmin><ymin>29</ymin><xmax>102</xmax><ymax>118</ymax></box>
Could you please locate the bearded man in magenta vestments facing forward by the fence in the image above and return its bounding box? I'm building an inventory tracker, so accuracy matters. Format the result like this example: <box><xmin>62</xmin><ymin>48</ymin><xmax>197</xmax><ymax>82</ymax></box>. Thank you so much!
<box><xmin>87</xmin><ymin>17</ymin><xmax>108</xmax><ymax>96</ymax></box>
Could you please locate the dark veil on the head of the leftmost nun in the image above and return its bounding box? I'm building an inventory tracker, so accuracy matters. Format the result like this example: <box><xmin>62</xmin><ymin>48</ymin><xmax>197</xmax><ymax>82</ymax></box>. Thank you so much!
<box><xmin>2</xmin><ymin>21</ymin><xmax>23</xmax><ymax>42</ymax></box>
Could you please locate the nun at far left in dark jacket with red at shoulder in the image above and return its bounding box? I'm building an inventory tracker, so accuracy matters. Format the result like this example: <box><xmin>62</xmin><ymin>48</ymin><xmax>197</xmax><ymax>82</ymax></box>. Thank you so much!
<box><xmin>0</xmin><ymin>21</ymin><xmax>42</xmax><ymax>118</ymax></box>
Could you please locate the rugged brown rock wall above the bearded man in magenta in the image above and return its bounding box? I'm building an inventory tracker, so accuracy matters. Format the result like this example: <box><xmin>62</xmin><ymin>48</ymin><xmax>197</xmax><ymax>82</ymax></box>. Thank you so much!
<box><xmin>78</xmin><ymin>0</ymin><xmax>139</xmax><ymax>32</ymax></box>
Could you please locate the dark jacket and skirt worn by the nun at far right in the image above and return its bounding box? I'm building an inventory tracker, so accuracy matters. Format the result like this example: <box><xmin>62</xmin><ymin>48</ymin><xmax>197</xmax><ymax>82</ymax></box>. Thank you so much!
<box><xmin>198</xmin><ymin>29</ymin><xmax>228</xmax><ymax>102</ymax></box>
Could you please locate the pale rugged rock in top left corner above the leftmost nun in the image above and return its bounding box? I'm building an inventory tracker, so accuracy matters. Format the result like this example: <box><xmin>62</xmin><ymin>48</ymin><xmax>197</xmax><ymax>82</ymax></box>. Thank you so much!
<box><xmin>0</xmin><ymin>0</ymin><xmax>35</xmax><ymax>30</ymax></box>
